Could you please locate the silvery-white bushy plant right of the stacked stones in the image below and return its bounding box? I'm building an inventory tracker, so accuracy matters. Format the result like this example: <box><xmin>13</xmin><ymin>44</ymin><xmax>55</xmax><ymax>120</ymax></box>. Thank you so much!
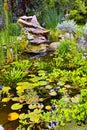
<box><xmin>56</xmin><ymin>20</ymin><xmax>77</xmax><ymax>33</ymax></box>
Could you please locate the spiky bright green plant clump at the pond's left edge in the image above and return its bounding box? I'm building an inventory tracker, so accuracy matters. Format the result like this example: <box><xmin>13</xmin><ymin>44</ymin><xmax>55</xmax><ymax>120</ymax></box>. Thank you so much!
<box><xmin>0</xmin><ymin>60</ymin><xmax>32</xmax><ymax>87</ymax></box>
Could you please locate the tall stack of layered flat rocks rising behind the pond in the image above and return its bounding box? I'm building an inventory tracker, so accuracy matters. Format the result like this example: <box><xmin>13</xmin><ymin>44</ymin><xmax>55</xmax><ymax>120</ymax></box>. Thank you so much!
<box><xmin>18</xmin><ymin>15</ymin><xmax>50</xmax><ymax>54</ymax></box>
